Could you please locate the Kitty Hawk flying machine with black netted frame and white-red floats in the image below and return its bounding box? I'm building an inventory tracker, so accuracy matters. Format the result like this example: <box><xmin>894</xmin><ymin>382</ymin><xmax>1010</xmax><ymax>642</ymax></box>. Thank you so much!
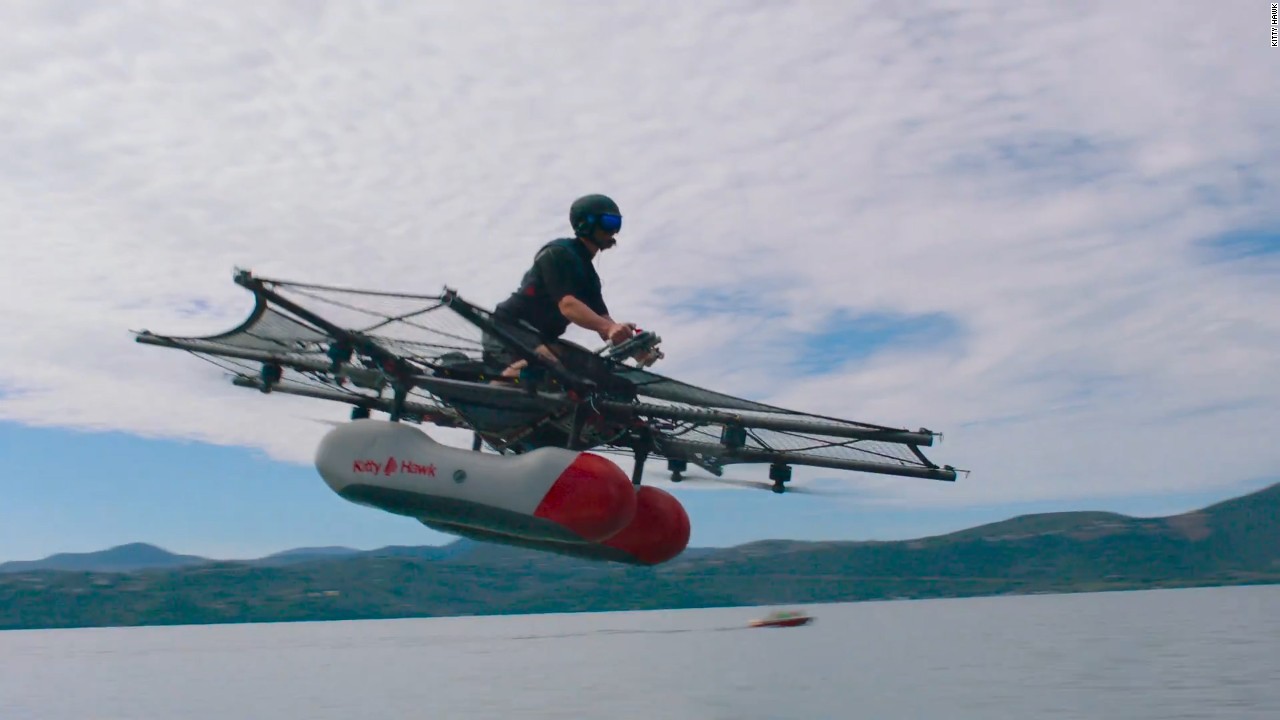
<box><xmin>136</xmin><ymin>270</ymin><xmax>956</xmax><ymax>565</ymax></box>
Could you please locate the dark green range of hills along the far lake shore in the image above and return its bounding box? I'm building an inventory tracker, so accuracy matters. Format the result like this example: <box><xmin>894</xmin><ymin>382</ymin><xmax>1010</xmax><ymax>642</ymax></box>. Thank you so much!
<box><xmin>0</xmin><ymin>486</ymin><xmax>1280</xmax><ymax>628</ymax></box>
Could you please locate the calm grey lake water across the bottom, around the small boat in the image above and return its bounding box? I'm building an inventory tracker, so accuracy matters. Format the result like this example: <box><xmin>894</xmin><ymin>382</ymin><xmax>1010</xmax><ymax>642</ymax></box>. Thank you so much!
<box><xmin>0</xmin><ymin>585</ymin><xmax>1280</xmax><ymax>720</ymax></box>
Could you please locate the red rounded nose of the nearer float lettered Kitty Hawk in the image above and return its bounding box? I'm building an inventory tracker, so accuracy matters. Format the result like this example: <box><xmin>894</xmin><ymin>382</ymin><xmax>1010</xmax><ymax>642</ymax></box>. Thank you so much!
<box><xmin>534</xmin><ymin>452</ymin><xmax>636</xmax><ymax>542</ymax></box>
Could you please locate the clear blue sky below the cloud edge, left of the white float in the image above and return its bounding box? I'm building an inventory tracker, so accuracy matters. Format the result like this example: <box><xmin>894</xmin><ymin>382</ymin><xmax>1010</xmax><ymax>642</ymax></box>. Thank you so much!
<box><xmin>0</xmin><ymin>421</ymin><xmax>449</xmax><ymax>562</ymax></box>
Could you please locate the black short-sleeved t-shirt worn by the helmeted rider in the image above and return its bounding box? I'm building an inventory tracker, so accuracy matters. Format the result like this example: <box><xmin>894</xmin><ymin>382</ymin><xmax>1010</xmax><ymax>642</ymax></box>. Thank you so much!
<box><xmin>494</xmin><ymin>237</ymin><xmax>609</xmax><ymax>338</ymax></box>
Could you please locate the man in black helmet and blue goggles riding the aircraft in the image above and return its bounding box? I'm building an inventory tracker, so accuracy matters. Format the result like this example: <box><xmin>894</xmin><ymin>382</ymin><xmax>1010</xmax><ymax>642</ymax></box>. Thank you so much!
<box><xmin>485</xmin><ymin>195</ymin><xmax>636</xmax><ymax>378</ymax></box>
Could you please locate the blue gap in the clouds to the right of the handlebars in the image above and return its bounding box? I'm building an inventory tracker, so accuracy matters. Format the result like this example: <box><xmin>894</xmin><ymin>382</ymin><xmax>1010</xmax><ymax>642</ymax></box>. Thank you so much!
<box><xmin>794</xmin><ymin>311</ymin><xmax>961</xmax><ymax>374</ymax></box>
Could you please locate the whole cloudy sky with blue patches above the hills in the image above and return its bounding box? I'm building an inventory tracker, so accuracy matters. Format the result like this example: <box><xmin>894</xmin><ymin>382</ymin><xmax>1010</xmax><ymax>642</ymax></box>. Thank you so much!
<box><xmin>0</xmin><ymin>0</ymin><xmax>1280</xmax><ymax>561</ymax></box>
